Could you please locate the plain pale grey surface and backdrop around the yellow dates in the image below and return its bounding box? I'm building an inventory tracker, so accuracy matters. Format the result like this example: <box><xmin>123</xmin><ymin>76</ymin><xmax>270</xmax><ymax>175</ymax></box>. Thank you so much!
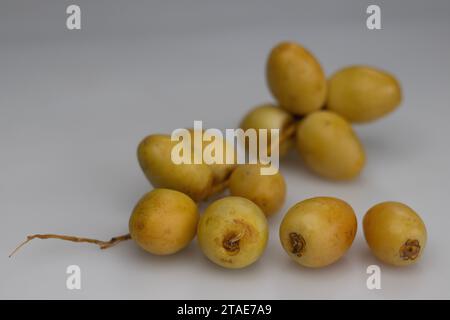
<box><xmin>0</xmin><ymin>0</ymin><xmax>450</xmax><ymax>299</ymax></box>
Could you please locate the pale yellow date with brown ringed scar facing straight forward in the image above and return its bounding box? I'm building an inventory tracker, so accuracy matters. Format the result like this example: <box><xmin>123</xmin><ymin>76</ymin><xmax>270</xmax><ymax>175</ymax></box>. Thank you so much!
<box><xmin>197</xmin><ymin>197</ymin><xmax>269</xmax><ymax>269</ymax></box>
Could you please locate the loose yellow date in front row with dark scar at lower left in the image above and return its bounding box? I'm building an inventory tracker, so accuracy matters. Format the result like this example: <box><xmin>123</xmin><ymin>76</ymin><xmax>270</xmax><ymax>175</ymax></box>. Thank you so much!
<box><xmin>280</xmin><ymin>197</ymin><xmax>357</xmax><ymax>268</ymax></box>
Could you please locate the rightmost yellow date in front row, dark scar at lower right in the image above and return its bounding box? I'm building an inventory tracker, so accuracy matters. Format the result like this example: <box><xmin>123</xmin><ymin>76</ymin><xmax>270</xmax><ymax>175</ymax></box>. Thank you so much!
<box><xmin>363</xmin><ymin>202</ymin><xmax>427</xmax><ymax>266</ymax></box>
